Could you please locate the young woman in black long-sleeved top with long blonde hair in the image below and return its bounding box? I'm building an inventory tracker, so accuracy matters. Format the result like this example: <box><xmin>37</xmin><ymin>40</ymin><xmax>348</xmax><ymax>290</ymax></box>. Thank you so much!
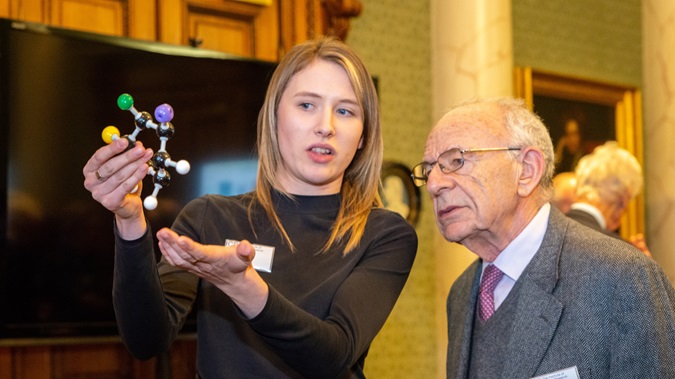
<box><xmin>83</xmin><ymin>39</ymin><xmax>417</xmax><ymax>378</ymax></box>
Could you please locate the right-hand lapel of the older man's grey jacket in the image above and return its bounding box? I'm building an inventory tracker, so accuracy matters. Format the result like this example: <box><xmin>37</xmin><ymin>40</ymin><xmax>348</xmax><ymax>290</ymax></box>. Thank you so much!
<box><xmin>502</xmin><ymin>209</ymin><xmax>569</xmax><ymax>378</ymax></box>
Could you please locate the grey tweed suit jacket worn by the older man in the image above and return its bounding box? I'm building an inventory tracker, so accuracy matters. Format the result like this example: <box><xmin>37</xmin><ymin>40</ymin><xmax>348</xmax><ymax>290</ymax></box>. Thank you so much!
<box><xmin>447</xmin><ymin>207</ymin><xmax>675</xmax><ymax>379</ymax></box>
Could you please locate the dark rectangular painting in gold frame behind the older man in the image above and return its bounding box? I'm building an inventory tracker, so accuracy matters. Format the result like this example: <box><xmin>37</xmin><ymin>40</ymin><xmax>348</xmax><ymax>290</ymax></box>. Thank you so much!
<box><xmin>514</xmin><ymin>67</ymin><xmax>644</xmax><ymax>238</ymax></box>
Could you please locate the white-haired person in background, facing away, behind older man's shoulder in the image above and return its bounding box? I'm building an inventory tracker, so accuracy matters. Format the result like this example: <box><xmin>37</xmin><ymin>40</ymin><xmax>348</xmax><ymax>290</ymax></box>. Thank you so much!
<box><xmin>567</xmin><ymin>141</ymin><xmax>651</xmax><ymax>257</ymax></box>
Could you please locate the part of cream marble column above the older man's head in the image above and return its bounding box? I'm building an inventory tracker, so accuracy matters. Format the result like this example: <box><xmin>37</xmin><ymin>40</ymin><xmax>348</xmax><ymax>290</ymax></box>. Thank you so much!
<box><xmin>431</xmin><ymin>0</ymin><xmax>513</xmax><ymax>119</ymax></box>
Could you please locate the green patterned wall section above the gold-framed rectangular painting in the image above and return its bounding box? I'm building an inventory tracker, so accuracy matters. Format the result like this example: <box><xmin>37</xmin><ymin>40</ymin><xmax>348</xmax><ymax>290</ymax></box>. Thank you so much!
<box><xmin>512</xmin><ymin>0</ymin><xmax>642</xmax><ymax>87</ymax></box>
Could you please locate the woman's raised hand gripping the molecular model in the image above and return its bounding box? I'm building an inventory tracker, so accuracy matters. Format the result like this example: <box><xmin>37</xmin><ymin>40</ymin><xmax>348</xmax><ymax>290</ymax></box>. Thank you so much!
<box><xmin>82</xmin><ymin>138</ymin><xmax>153</xmax><ymax>240</ymax></box>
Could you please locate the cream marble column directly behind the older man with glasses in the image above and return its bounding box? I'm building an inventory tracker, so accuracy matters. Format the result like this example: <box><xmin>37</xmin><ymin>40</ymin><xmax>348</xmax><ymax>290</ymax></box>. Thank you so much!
<box><xmin>431</xmin><ymin>0</ymin><xmax>513</xmax><ymax>378</ymax></box>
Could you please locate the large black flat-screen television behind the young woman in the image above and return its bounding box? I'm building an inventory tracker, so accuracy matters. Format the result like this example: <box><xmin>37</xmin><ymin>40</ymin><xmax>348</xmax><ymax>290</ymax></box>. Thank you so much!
<box><xmin>0</xmin><ymin>19</ymin><xmax>274</xmax><ymax>342</ymax></box>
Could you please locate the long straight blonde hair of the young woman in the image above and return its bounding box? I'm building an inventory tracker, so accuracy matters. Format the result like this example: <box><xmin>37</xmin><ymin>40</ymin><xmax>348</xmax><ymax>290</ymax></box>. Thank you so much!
<box><xmin>254</xmin><ymin>37</ymin><xmax>382</xmax><ymax>254</ymax></box>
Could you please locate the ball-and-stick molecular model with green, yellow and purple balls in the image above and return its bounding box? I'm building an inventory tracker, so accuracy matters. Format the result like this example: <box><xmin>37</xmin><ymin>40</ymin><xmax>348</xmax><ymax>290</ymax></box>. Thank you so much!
<box><xmin>101</xmin><ymin>93</ymin><xmax>190</xmax><ymax>210</ymax></box>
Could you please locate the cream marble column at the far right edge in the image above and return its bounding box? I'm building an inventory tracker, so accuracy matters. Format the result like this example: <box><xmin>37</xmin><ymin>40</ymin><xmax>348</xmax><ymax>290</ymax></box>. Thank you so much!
<box><xmin>642</xmin><ymin>0</ymin><xmax>675</xmax><ymax>282</ymax></box>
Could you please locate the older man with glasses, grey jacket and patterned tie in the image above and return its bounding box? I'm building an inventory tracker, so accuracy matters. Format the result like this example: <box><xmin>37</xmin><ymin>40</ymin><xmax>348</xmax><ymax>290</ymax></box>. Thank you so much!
<box><xmin>413</xmin><ymin>99</ymin><xmax>675</xmax><ymax>379</ymax></box>
